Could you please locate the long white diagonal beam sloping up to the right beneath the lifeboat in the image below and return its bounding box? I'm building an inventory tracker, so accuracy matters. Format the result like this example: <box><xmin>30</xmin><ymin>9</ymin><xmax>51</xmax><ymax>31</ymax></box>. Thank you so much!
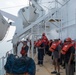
<box><xmin>17</xmin><ymin>1</ymin><xmax>69</xmax><ymax>37</ymax></box>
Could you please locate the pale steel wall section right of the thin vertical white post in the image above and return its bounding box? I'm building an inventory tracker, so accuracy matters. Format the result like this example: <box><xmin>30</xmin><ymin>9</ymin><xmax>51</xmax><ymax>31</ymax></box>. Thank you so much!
<box><xmin>61</xmin><ymin>0</ymin><xmax>76</xmax><ymax>39</ymax></box>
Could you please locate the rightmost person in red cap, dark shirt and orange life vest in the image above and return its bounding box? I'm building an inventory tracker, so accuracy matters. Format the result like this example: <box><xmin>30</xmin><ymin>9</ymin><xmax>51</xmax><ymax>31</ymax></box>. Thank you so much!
<box><xmin>61</xmin><ymin>38</ymin><xmax>75</xmax><ymax>75</ymax></box>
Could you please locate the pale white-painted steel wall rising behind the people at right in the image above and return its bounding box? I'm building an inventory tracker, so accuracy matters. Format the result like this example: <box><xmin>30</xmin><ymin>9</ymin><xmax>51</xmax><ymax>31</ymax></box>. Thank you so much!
<box><xmin>42</xmin><ymin>0</ymin><xmax>76</xmax><ymax>40</ymax></box>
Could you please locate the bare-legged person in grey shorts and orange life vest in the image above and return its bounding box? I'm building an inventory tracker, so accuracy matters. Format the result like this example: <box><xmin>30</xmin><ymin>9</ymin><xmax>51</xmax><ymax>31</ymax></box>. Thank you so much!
<box><xmin>50</xmin><ymin>39</ymin><xmax>61</xmax><ymax>75</ymax></box>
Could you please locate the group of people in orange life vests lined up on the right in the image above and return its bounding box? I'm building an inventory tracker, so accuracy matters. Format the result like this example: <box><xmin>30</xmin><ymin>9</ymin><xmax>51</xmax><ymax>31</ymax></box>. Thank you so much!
<box><xmin>35</xmin><ymin>34</ymin><xmax>75</xmax><ymax>75</ymax></box>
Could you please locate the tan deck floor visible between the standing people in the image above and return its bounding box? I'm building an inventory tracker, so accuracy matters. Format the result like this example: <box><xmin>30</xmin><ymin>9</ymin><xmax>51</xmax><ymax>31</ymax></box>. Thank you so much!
<box><xmin>35</xmin><ymin>55</ymin><xmax>76</xmax><ymax>75</ymax></box>
